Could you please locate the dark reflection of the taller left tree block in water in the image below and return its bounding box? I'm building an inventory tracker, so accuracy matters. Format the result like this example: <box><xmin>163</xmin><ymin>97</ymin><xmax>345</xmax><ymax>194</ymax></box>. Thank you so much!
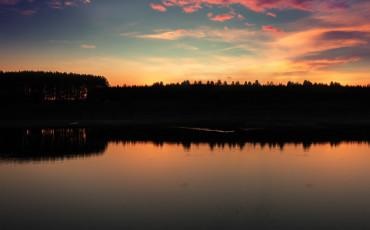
<box><xmin>0</xmin><ymin>129</ymin><xmax>107</xmax><ymax>161</ymax></box>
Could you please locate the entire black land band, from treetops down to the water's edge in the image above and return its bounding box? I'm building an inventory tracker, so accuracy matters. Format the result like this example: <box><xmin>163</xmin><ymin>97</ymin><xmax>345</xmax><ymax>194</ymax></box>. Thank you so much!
<box><xmin>0</xmin><ymin>71</ymin><xmax>370</xmax><ymax>139</ymax></box>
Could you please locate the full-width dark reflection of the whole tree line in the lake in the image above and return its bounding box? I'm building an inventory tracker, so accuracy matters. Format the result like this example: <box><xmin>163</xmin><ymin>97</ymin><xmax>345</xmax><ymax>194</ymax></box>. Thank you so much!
<box><xmin>0</xmin><ymin>127</ymin><xmax>370</xmax><ymax>162</ymax></box>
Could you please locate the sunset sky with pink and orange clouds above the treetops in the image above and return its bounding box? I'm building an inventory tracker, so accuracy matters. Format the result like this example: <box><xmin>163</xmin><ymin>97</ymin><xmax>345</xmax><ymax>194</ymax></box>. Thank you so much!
<box><xmin>0</xmin><ymin>0</ymin><xmax>370</xmax><ymax>85</ymax></box>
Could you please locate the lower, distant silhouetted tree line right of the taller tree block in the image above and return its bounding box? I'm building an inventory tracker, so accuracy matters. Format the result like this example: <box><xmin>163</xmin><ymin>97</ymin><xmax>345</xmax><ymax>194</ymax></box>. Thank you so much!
<box><xmin>88</xmin><ymin>81</ymin><xmax>370</xmax><ymax>110</ymax></box>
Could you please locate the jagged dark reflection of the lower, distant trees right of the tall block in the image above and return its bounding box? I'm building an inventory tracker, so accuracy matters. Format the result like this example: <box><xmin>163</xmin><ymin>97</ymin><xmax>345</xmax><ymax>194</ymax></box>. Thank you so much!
<box><xmin>100</xmin><ymin>128</ymin><xmax>370</xmax><ymax>151</ymax></box>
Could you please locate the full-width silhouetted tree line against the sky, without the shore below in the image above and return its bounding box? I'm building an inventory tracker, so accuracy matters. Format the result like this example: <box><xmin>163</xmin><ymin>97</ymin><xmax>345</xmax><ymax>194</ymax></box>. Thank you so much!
<box><xmin>0</xmin><ymin>71</ymin><xmax>370</xmax><ymax>109</ymax></box>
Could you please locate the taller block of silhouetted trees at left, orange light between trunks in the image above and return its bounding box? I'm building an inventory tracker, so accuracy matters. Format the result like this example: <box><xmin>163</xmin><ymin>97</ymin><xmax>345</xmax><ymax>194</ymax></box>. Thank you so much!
<box><xmin>0</xmin><ymin>71</ymin><xmax>108</xmax><ymax>103</ymax></box>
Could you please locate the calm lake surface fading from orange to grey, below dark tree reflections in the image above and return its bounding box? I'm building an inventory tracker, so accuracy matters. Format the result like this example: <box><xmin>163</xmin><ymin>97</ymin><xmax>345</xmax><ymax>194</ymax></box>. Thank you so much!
<box><xmin>0</xmin><ymin>136</ymin><xmax>370</xmax><ymax>230</ymax></box>
